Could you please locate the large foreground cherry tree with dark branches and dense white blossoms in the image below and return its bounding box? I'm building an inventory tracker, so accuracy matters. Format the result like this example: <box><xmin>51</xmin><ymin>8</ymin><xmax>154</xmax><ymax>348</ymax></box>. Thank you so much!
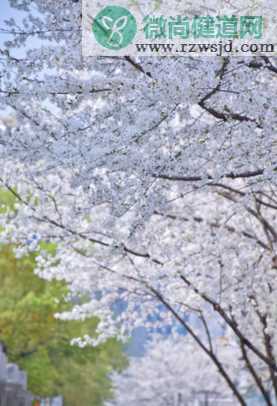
<box><xmin>0</xmin><ymin>0</ymin><xmax>277</xmax><ymax>406</ymax></box>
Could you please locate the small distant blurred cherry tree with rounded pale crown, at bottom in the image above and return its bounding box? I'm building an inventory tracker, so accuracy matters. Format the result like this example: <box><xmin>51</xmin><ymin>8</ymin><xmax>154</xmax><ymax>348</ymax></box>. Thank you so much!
<box><xmin>106</xmin><ymin>337</ymin><xmax>243</xmax><ymax>406</ymax></box>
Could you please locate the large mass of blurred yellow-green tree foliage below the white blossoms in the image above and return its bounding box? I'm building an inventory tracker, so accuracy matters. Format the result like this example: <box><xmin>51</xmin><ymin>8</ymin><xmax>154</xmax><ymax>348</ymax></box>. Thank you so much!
<box><xmin>0</xmin><ymin>244</ymin><xmax>126</xmax><ymax>406</ymax></box>
